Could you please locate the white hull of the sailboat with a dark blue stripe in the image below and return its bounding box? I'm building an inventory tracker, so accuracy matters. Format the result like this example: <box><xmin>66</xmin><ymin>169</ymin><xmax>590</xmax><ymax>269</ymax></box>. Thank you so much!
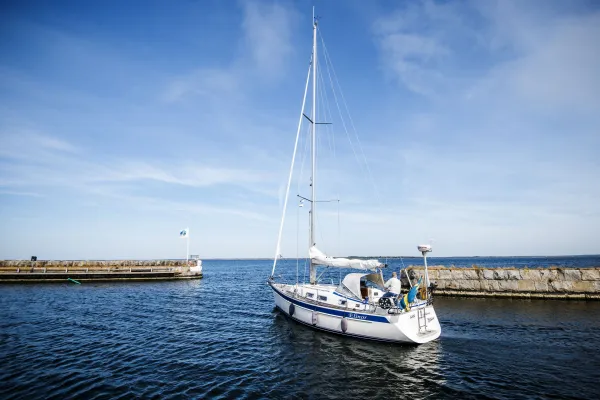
<box><xmin>269</xmin><ymin>282</ymin><xmax>441</xmax><ymax>344</ymax></box>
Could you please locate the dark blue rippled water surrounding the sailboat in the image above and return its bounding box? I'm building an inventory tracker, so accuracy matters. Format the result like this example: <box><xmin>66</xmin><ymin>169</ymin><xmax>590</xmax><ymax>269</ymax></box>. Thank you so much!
<box><xmin>0</xmin><ymin>260</ymin><xmax>600</xmax><ymax>399</ymax></box>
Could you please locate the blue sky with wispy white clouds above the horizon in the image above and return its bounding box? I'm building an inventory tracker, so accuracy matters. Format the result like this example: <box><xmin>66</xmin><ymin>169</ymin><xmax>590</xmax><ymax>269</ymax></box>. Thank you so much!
<box><xmin>0</xmin><ymin>1</ymin><xmax>600</xmax><ymax>259</ymax></box>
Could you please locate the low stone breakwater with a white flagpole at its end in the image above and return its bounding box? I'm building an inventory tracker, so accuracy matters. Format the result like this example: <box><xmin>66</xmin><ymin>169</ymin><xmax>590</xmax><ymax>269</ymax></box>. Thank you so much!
<box><xmin>0</xmin><ymin>260</ymin><xmax>202</xmax><ymax>282</ymax></box>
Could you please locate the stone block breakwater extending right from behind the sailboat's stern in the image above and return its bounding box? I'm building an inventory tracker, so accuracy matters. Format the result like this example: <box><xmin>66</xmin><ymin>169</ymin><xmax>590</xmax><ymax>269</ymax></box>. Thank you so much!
<box><xmin>402</xmin><ymin>266</ymin><xmax>600</xmax><ymax>300</ymax></box>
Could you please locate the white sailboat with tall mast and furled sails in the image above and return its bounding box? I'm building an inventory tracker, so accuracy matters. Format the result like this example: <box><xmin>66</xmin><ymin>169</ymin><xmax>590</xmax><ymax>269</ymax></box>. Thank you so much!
<box><xmin>267</xmin><ymin>14</ymin><xmax>441</xmax><ymax>344</ymax></box>
